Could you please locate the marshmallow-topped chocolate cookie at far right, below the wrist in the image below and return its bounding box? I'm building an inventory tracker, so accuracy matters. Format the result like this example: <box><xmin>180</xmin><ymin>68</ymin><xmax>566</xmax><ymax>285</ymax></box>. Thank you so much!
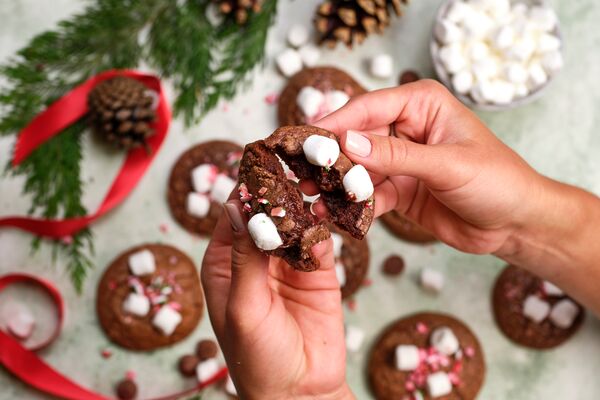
<box><xmin>492</xmin><ymin>265</ymin><xmax>585</xmax><ymax>349</ymax></box>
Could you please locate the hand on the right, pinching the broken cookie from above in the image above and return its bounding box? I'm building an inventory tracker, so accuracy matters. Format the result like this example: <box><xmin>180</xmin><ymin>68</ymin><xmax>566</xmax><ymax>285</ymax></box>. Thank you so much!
<box><xmin>314</xmin><ymin>80</ymin><xmax>542</xmax><ymax>253</ymax></box>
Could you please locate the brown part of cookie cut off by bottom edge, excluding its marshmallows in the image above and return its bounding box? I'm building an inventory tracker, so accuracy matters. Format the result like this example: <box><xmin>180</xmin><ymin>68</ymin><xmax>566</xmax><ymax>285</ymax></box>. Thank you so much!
<box><xmin>368</xmin><ymin>313</ymin><xmax>485</xmax><ymax>400</ymax></box>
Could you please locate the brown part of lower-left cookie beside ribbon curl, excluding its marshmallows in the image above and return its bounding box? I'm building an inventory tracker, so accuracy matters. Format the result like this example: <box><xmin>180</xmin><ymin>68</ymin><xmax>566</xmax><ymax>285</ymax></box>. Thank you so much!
<box><xmin>96</xmin><ymin>244</ymin><xmax>204</xmax><ymax>350</ymax></box>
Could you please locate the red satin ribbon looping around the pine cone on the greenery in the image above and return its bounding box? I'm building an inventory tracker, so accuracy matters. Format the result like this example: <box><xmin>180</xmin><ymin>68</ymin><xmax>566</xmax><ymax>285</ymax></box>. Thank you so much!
<box><xmin>0</xmin><ymin>70</ymin><xmax>171</xmax><ymax>238</ymax></box>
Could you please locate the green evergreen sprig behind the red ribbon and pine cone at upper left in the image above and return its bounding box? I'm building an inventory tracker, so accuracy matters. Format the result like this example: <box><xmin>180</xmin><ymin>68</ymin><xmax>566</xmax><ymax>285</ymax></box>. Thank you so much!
<box><xmin>0</xmin><ymin>0</ymin><xmax>277</xmax><ymax>291</ymax></box>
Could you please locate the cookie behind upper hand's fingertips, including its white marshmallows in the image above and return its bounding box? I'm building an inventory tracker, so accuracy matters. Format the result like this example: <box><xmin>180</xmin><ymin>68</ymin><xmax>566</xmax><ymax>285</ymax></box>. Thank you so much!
<box><xmin>277</xmin><ymin>67</ymin><xmax>366</xmax><ymax>126</ymax></box>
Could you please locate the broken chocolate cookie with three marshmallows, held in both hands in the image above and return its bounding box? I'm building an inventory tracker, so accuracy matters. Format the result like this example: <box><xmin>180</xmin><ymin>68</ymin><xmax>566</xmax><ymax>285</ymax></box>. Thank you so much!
<box><xmin>239</xmin><ymin>126</ymin><xmax>374</xmax><ymax>271</ymax></box>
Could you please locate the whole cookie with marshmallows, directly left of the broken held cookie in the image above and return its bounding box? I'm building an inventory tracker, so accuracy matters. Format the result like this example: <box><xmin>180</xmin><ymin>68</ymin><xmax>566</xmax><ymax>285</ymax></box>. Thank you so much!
<box><xmin>167</xmin><ymin>140</ymin><xmax>242</xmax><ymax>235</ymax></box>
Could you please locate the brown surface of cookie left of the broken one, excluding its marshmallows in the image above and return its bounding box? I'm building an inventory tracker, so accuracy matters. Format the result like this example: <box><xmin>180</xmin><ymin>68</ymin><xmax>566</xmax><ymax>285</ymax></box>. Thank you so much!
<box><xmin>167</xmin><ymin>140</ymin><xmax>242</xmax><ymax>235</ymax></box>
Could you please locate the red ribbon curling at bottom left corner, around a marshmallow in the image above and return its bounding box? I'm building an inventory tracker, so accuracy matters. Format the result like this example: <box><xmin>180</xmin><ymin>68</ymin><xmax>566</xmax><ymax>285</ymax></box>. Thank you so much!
<box><xmin>0</xmin><ymin>274</ymin><xmax>227</xmax><ymax>400</ymax></box>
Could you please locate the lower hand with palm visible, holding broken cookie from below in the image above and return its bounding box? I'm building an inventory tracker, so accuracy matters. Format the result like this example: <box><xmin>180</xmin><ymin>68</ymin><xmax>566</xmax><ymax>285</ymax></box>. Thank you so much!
<box><xmin>202</xmin><ymin>200</ymin><xmax>353</xmax><ymax>400</ymax></box>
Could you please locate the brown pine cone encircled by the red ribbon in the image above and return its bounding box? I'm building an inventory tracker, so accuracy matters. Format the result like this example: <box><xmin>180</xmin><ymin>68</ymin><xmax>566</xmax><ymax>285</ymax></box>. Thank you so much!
<box><xmin>88</xmin><ymin>76</ymin><xmax>155</xmax><ymax>149</ymax></box>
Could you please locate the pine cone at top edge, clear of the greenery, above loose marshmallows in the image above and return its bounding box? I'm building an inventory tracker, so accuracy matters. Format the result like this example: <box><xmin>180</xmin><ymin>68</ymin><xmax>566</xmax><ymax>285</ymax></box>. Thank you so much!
<box><xmin>315</xmin><ymin>0</ymin><xmax>408</xmax><ymax>48</ymax></box>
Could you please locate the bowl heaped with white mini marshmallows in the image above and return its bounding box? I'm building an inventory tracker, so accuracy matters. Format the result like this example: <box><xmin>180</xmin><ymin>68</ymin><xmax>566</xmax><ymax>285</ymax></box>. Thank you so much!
<box><xmin>430</xmin><ymin>0</ymin><xmax>563</xmax><ymax>111</ymax></box>
